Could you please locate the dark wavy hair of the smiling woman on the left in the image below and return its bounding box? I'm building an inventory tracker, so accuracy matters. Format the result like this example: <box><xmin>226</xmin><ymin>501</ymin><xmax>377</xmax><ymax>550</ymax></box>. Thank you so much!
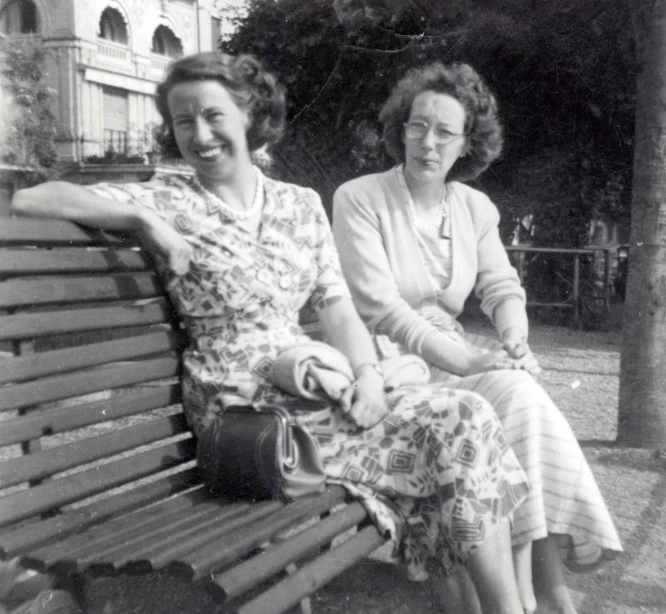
<box><xmin>155</xmin><ymin>51</ymin><xmax>286</xmax><ymax>158</ymax></box>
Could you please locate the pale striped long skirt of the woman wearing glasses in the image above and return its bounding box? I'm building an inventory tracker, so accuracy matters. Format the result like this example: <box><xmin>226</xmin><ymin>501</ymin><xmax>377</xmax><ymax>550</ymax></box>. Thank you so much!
<box><xmin>432</xmin><ymin>333</ymin><xmax>622</xmax><ymax>571</ymax></box>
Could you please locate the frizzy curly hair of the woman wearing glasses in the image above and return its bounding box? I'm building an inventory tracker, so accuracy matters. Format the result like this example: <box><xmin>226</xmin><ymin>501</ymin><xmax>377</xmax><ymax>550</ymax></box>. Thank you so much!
<box><xmin>379</xmin><ymin>62</ymin><xmax>502</xmax><ymax>181</ymax></box>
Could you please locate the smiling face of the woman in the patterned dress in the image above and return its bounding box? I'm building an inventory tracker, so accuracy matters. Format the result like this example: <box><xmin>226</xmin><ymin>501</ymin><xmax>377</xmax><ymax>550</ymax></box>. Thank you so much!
<box><xmin>167</xmin><ymin>79</ymin><xmax>251</xmax><ymax>182</ymax></box>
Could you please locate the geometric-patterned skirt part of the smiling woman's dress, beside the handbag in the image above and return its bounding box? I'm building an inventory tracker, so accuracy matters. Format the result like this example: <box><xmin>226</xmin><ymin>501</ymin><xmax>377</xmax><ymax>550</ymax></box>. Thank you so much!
<box><xmin>297</xmin><ymin>384</ymin><xmax>529</xmax><ymax>580</ymax></box>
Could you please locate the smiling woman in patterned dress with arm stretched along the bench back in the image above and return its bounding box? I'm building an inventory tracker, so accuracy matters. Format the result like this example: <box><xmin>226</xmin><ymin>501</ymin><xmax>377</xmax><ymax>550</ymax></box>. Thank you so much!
<box><xmin>12</xmin><ymin>53</ymin><xmax>528</xmax><ymax>614</ymax></box>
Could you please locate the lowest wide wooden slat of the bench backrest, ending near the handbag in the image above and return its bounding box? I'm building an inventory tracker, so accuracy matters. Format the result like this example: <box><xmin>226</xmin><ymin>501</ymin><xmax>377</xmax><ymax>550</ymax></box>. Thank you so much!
<box><xmin>0</xmin><ymin>439</ymin><xmax>194</xmax><ymax>527</ymax></box>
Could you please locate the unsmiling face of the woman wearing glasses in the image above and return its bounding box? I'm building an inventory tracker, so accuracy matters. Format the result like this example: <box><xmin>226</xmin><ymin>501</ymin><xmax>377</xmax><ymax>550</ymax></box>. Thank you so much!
<box><xmin>403</xmin><ymin>90</ymin><xmax>467</xmax><ymax>188</ymax></box>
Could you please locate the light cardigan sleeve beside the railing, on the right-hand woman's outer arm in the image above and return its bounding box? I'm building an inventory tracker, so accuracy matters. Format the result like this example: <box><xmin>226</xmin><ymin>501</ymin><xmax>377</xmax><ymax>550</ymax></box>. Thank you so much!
<box><xmin>472</xmin><ymin>192</ymin><xmax>528</xmax><ymax>338</ymax></box>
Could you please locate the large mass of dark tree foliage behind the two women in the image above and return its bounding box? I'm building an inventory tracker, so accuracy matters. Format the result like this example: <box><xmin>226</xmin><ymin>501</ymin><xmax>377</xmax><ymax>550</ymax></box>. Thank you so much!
<box><xmin>223</xmin><ymin>0</ymin><xmax>635</xmax><ymax>247</ymax></box>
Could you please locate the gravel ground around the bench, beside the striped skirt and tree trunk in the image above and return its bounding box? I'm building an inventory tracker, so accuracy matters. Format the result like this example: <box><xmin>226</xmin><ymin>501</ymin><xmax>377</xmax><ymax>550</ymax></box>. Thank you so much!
<box><xmin>315</xmin><ymin>322</ymin><xmax>666</xmax><ymax>614</ymax></box>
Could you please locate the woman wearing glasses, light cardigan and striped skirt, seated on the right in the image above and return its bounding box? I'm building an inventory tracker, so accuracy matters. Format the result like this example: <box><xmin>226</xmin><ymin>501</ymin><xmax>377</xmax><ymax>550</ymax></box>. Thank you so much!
<box><xmin>333</xmin><ymin>63</ymin><xmax>621</xmax><ymax>614</ymax></box>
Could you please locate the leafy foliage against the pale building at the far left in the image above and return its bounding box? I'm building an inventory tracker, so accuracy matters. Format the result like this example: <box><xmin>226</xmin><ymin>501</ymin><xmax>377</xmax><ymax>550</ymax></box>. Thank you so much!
<box><xmin>0</xmin><ymin>40</ymin><xmax>60</xmax><ymax>183</ymax></box>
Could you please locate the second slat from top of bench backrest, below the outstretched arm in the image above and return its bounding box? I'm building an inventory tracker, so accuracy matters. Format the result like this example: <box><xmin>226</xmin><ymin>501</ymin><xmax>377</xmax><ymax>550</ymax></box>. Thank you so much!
<box><xmin>0</xmin><ymin>248</ymin><xmax>148</xmax><ymax>276</ymax></box>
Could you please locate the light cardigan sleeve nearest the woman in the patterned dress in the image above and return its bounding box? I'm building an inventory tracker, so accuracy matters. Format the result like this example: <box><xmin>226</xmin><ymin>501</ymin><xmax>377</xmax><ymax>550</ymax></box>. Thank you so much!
<box><xmin>333</xmin><ymin>180</ymin><xmax>438</xmax><ymax>355</ymax></box>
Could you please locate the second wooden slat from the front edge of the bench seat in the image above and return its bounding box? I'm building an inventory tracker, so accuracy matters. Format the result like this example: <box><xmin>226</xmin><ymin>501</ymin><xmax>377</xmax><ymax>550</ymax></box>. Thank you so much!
<box><xmin>210</xmin><ymin>501</ymin><xmax>368</xmax><ymax>601</ymax></box>
